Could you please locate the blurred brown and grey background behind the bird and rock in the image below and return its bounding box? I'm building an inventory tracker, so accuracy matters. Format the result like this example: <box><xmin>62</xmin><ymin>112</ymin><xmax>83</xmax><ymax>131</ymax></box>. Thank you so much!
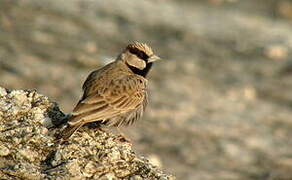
<box><xmin>0</xmin><ymin>0</ymin><xmax>292</xmax><ymax>180</ymax></box>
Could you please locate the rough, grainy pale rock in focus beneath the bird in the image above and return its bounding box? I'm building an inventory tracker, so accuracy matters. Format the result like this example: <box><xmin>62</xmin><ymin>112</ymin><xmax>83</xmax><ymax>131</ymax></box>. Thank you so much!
<box><xmin>0</xmin><ymin>87</ymin><xmax>174</xmax><ymax>180</ymax></box>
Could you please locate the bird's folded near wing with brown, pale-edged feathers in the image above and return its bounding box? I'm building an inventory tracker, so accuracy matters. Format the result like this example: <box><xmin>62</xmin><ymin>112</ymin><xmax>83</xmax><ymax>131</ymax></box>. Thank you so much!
<box><xmin>69</xmin><ymin>75</ymin><xmax>147</xmax><ymax>125</ymax></box>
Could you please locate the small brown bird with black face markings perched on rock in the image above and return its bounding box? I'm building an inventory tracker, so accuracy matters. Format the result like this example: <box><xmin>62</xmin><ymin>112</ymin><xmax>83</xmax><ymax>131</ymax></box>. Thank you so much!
<box><xmin>61</xmin><ymin>42</ymin><xmax>160</xmax><ymax>140</ymax></box>
